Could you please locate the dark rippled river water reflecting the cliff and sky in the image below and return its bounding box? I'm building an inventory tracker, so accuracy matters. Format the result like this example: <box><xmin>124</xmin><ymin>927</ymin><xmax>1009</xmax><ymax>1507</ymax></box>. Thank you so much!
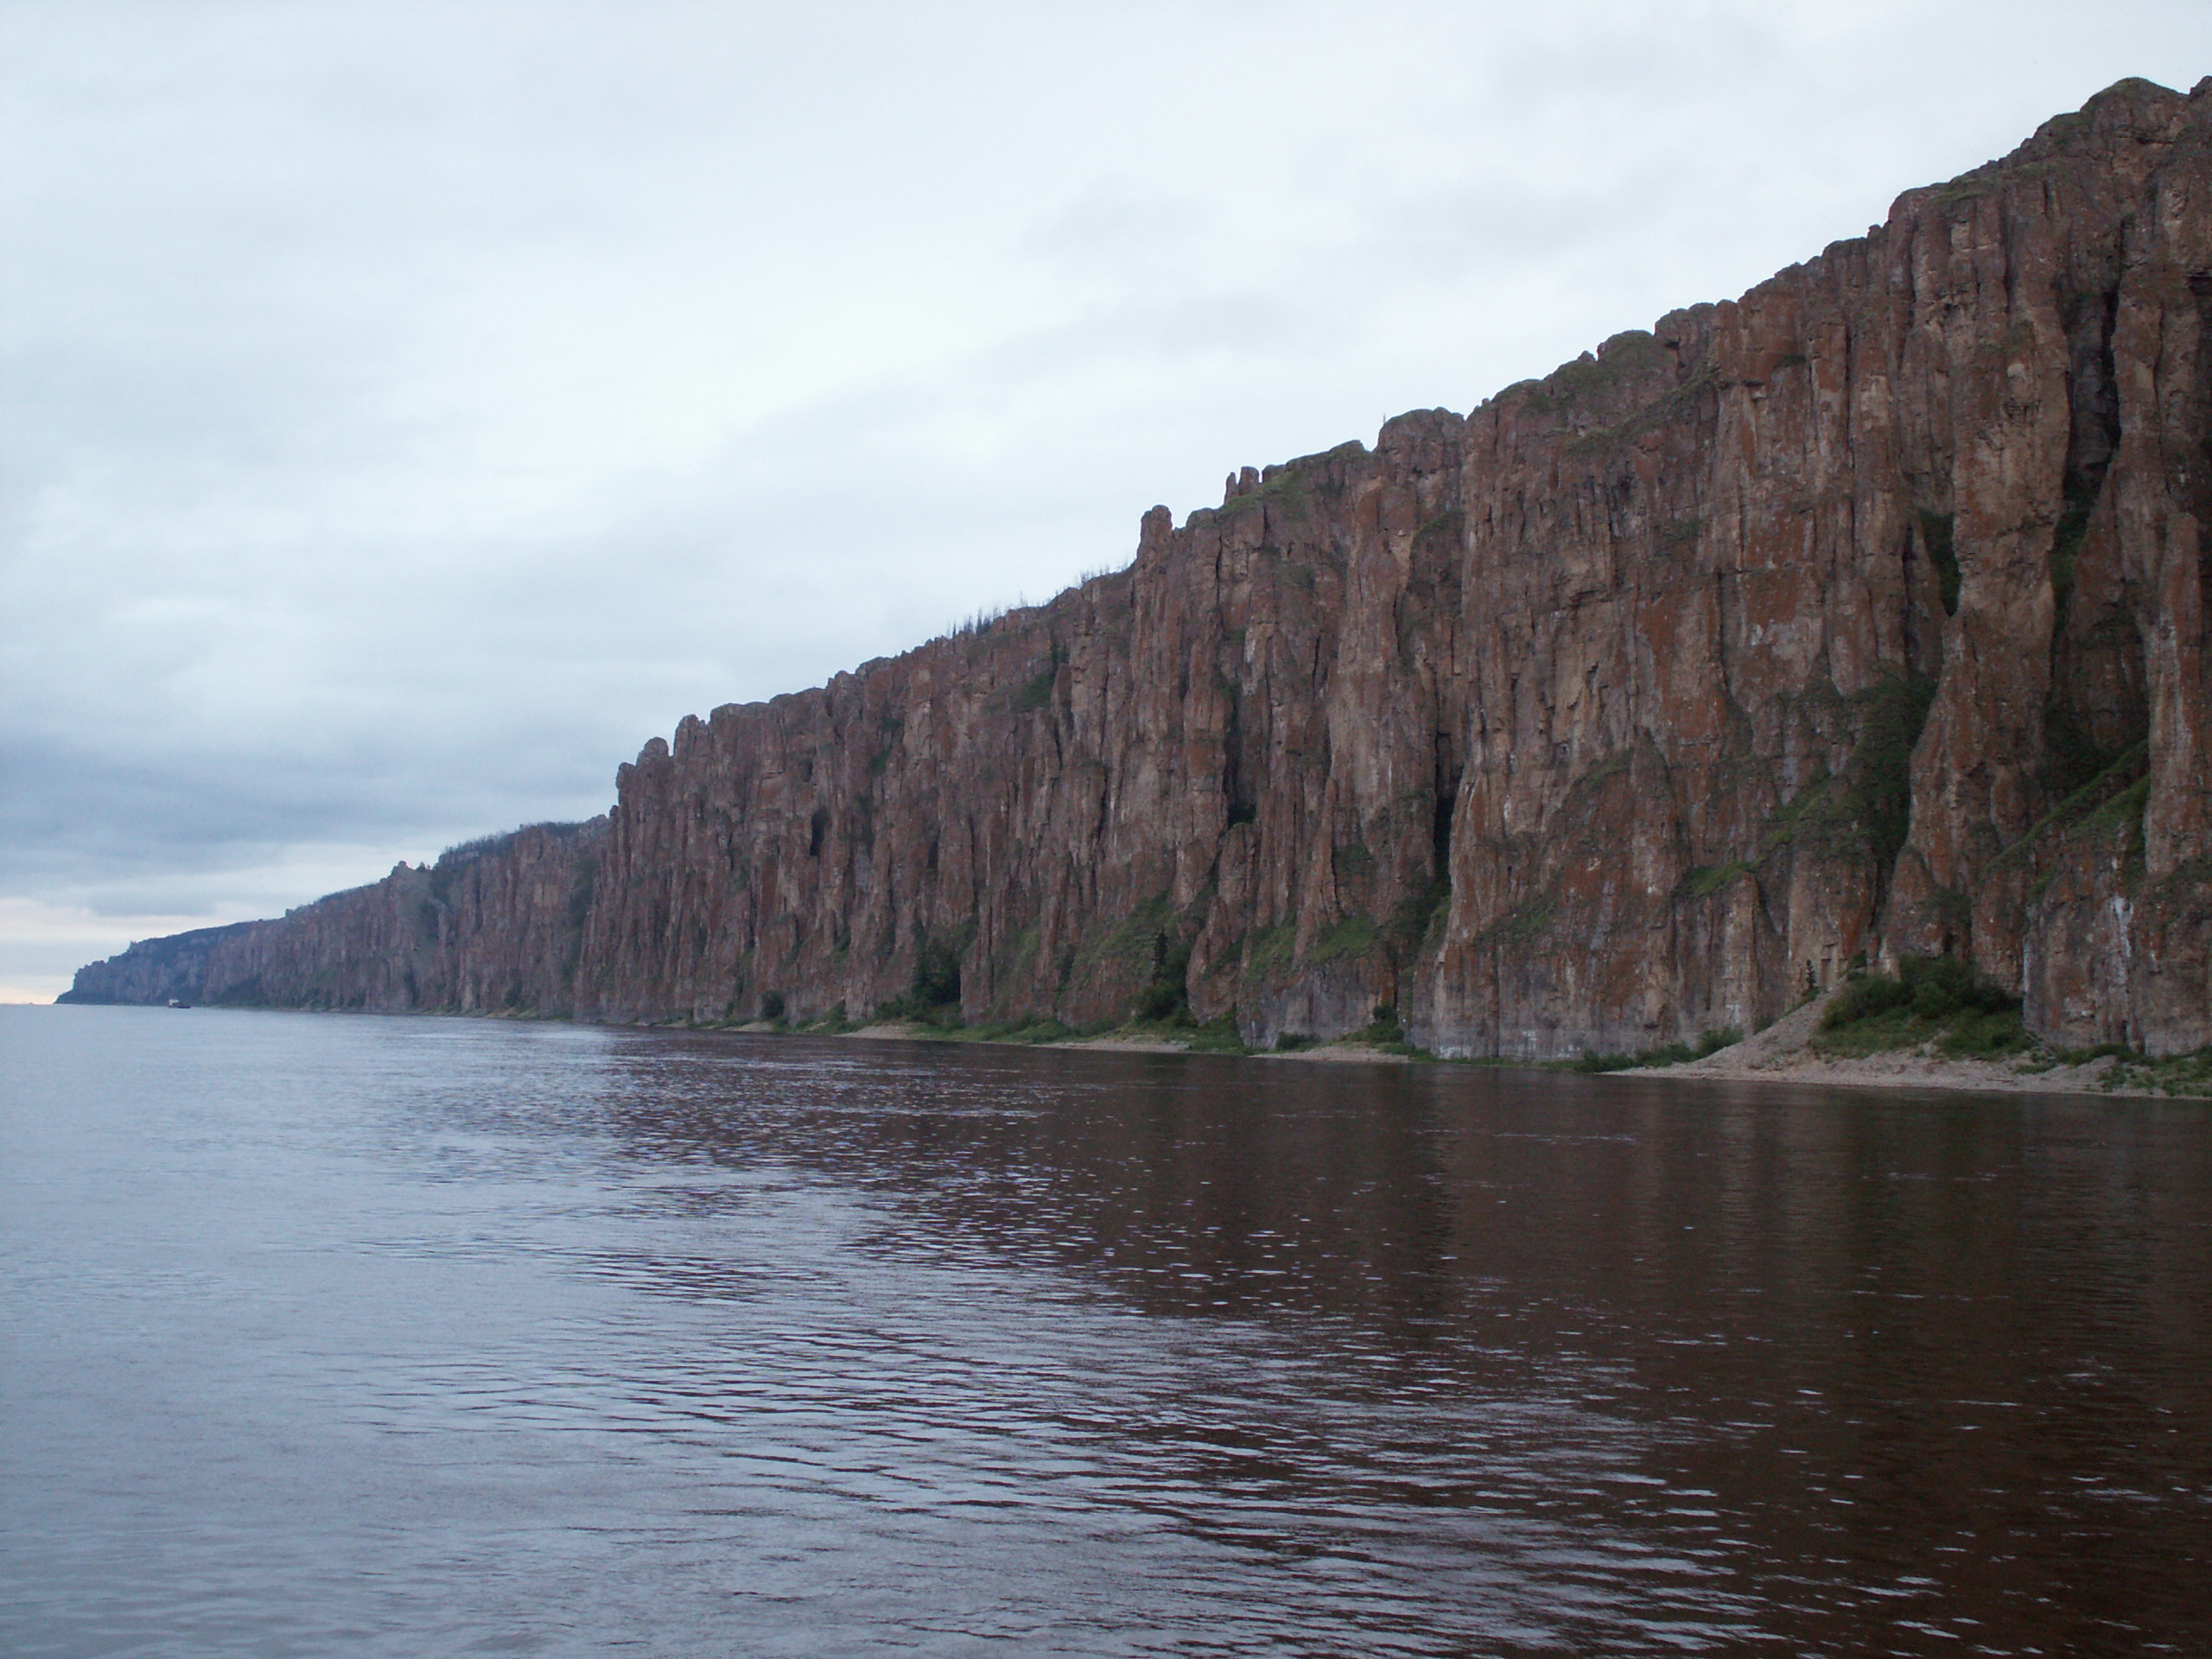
<box><xmin>0</xmin><ymin>1008</ymin><xmax>2212</xmax><ymax>1659</ymax></box>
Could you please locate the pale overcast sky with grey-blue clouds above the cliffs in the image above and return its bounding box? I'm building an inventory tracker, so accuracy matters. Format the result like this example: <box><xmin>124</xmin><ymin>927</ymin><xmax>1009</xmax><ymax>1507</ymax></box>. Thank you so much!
<box><xmin>0</xmin><ymin>0</ymin><xmax>2212</xmax><ymax>1002</ymax></box>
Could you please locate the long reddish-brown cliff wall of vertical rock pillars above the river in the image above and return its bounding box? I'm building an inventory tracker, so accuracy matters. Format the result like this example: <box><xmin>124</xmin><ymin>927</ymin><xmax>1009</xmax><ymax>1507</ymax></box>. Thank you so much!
<box><xmin>64</xmin><ymin>82</ymin><xmax>2212</xmax><ymax>1058</ymax></box>
